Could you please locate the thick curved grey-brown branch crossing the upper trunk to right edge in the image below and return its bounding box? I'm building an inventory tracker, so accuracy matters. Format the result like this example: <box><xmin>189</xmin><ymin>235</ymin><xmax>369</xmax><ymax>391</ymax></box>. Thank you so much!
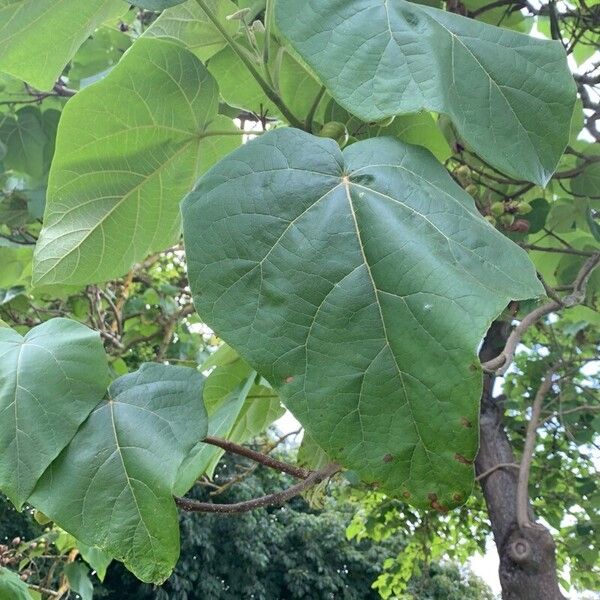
<box><xmin>481</xmin><ymin>252</ymin><xmax>600</xmax><ymax>375</ymax></box>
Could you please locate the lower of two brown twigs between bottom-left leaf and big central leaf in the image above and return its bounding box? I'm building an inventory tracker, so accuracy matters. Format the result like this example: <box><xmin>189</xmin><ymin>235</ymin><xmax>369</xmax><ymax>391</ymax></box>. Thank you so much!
<box><xmin>175</xmin><ymin>464</ymin><xmax>340</xmax><ymax>514</ymax></box>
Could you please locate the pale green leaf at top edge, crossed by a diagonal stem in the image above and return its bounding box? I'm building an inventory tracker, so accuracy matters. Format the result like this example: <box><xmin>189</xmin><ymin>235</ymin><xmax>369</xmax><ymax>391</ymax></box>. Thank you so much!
<box><xmin>144</xmin><ymin>0</ymin><xmax>239</xmax><ymax>61</ymax></box>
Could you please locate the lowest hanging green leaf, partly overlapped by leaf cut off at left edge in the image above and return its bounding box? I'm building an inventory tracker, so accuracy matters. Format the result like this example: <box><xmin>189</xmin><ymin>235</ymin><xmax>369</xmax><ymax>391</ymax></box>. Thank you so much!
<box><xmin>30</xmin><ymin>364</ymin><xmax>207</xmax><ymax>582</ymax></box>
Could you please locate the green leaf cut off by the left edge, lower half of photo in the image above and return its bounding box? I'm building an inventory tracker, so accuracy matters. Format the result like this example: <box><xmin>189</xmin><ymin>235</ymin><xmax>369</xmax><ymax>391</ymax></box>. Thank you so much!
<box><xmin>0</xmin><ymin>319</ymin><xmax>109</xmax><ymax>507</ymax></box>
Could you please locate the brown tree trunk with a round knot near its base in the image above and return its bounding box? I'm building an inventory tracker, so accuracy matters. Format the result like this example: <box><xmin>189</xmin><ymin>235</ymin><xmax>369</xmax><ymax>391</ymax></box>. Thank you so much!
<box><xmin>475</xmin><ymin>322</ymin><xmax>565</xmax><ymax>600</ymax></box>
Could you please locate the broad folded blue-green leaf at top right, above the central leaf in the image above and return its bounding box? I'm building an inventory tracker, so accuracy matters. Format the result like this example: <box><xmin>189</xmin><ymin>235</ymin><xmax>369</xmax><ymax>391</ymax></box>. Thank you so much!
<box><xmin>276</xmin><ymin>0</ymin><xmax>575</xmax><ymax>185</ymax></box>
